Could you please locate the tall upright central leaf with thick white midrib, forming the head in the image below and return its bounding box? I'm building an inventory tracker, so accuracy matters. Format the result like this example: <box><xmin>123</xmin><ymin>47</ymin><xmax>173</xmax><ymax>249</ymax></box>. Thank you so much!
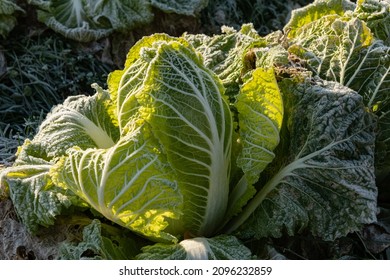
<box><xmin>136</xmin><ymin>41</ymin><xmax>232</xmax><ymax>236</ymax></box>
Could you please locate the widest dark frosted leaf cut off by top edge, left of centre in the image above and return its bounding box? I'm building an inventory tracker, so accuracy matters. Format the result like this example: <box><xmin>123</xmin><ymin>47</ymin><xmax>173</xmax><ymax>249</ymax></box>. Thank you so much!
<box><xmin>29</xmin><ymin>0</ymin><xmax>153</xmax><ymax>42</ymax></box>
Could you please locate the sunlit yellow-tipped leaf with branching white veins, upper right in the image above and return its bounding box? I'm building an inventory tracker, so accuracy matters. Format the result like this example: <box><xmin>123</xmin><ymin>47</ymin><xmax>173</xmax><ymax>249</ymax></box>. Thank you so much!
<box><xmin>289</xmin><ymin>15</ymin><xmax>374</xmax><ymax>86</ymax></box>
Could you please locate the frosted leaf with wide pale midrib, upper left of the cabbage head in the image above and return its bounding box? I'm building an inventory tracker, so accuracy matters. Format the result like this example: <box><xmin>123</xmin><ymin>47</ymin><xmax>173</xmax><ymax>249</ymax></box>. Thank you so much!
<box><xmin>33</xmin><ymin>87</ymin><xmax>119</xmax><ymax>157</ymax></box>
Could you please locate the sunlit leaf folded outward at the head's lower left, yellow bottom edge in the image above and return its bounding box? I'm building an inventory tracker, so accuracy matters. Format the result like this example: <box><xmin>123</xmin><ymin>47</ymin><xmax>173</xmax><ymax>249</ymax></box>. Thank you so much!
<box><xmin>50</xmin><ymin>126</ymin><xmax>182</xmax><ymax>241</ymax></box>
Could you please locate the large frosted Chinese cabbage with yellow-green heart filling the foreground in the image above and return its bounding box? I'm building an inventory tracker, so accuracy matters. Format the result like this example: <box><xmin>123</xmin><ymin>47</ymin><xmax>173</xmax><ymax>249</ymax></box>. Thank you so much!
<box><xmin>1</xmin><ymin>1</ymin><xmax>387</xmax><ymax>259</ymax></box>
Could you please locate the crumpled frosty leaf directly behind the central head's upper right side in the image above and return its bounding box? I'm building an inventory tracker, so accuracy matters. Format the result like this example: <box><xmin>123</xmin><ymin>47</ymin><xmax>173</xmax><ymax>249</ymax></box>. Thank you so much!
<box><xmin>184</xmin><ymin>24</ymin><xmax>266</xmax><ymax>97</ymax></box>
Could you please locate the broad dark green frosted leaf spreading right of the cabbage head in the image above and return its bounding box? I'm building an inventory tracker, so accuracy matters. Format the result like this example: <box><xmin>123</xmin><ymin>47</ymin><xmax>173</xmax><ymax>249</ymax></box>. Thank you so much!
<box><xmin>226</xmin><ymin>81</ymin><xmax>377</xmax><ymax>240</ymax></box>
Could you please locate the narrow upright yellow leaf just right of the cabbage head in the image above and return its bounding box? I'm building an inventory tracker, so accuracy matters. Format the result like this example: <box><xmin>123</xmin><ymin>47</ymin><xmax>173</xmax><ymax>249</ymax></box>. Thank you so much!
<box><xmin>225</xmin><ymin>68</ymin><xmax>283</xmax><ymax>219</ymax></box>
